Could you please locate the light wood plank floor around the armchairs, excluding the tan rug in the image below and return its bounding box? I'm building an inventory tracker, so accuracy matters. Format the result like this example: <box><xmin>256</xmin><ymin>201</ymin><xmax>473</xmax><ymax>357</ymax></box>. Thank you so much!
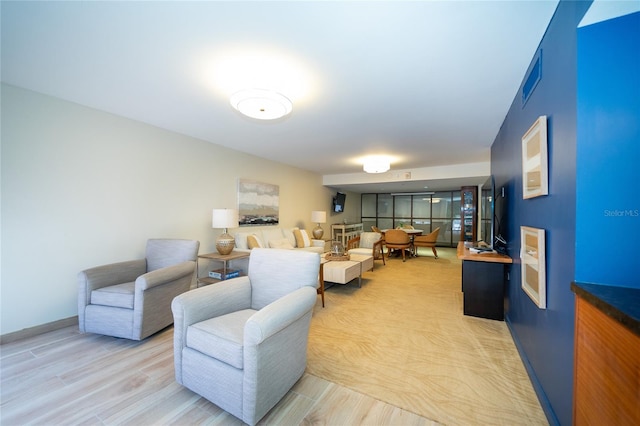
<box><xmin>0</xmin><ymin>327</ymin><xmax>436</xmax><ymax>426</ymax></box>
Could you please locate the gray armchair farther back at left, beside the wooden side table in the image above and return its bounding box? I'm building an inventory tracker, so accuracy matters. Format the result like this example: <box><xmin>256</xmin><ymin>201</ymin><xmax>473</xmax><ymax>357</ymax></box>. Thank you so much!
<box><xmin>78</xmin><ymin>239</ymin><xmax>200</xmax><ymax>340</ymax></box>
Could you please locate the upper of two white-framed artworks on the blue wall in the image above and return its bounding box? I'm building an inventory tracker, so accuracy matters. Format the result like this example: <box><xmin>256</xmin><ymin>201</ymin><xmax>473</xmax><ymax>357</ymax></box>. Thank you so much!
<box><xmin>522</xmin><ymin>115</ymin><xmax>549</xmax><ymax>199</ymax></box>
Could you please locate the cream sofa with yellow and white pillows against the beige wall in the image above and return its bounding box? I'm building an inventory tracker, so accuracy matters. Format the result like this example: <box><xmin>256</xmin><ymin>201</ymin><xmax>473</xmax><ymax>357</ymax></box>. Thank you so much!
<box><xmin>234</xmin><ymin>226</ymin><xmax>324</xmax><ymax>254</ymax></box>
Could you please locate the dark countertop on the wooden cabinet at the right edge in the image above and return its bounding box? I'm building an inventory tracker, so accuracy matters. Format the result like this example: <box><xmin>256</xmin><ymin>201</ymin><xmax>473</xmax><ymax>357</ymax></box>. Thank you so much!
<box><xmin>571</xmin><ymin>282</ymin><xmax>640</xmax><ymax>336</ymax></box>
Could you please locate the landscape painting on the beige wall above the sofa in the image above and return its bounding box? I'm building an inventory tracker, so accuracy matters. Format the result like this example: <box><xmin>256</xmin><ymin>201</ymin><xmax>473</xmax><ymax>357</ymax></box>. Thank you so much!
<box><xmin>238</xmin><ymin>179</ymin><xmax>280</xmax><ymax>226</ymax></box>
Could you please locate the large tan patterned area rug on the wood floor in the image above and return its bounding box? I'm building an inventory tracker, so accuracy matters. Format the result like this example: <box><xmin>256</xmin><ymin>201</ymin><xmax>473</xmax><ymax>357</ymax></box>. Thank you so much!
<box><xmin>307</xmin><ymin>248</ymin><xmax>547</xmax><ymax>425</ymax></box>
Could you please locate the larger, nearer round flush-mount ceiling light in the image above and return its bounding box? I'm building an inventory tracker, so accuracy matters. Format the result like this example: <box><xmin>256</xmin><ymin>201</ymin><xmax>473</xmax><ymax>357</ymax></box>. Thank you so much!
<box><xmin>230</xmin><ymin>89</ymin><xmax>293</xmax><ymax>120</ymax></box>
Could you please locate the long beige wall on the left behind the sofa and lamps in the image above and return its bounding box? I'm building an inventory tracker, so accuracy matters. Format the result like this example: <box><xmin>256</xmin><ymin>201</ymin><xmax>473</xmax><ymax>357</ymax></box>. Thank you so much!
<box><xmin>0</xmin><ymin>85</ymin><xmax>360</xmax><ymax>335</ymax></box>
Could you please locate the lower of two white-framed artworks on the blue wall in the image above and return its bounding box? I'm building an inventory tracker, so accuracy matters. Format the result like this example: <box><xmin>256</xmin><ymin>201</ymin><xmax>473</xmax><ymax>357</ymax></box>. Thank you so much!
<box><xmin>520</xmin><ymin>226</ymin><xmax>547</xmax><ymax>309</ymax></box>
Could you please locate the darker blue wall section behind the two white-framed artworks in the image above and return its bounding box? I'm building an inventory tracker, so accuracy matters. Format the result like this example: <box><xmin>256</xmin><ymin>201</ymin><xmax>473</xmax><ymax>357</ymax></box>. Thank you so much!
<box><xmin>491</xmin><ymin>1</ymin><xmax>601</xmax><ymax>425</ymax></box>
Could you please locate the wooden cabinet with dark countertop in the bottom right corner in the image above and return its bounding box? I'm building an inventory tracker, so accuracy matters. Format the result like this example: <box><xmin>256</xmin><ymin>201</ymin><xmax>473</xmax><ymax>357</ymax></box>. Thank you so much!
<box><xmin>571</xmin><ymin>283</ymin><xmax>640</xmax><ymax>426</ymax></box>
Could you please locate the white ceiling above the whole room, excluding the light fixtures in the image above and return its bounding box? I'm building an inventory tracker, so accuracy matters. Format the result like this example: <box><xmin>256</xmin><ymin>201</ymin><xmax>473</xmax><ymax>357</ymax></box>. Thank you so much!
<box><xmin>1</xmin><ymin>0</ymin><xmax>557</xmax><ymax>191</ymax></box>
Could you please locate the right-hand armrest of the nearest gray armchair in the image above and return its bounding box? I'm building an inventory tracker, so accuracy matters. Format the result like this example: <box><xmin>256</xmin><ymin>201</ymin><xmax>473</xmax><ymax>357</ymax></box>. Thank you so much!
<box><xmin>244</xmin><ymin>286</ymin><xmax>317</xmax><ymax>347</ymax></box>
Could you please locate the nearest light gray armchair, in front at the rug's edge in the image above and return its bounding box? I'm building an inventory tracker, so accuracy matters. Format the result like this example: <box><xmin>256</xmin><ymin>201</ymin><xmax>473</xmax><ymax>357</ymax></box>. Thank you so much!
<box><xmin>171</xmin><ymin>248</ymin><xmax>320</xmax><ymax>425</ymax></box>
